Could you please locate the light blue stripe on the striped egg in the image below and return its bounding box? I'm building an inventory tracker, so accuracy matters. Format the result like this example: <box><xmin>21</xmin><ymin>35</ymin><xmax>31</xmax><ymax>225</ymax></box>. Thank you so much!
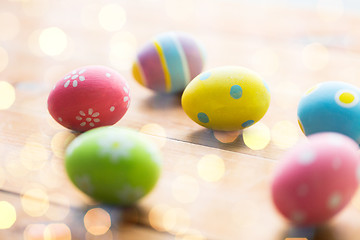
<box><xmin>157</xmin><ymin>34</ymin><xmax>186</xmax><ymax>92</ymax></box>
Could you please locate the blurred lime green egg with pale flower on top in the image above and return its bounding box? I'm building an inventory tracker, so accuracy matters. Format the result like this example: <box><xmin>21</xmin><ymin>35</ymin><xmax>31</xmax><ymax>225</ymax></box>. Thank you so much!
<box><xmin>65</xmin><ymin>127</ymin><xmax>161</xmax><ymax>206</ymax></box>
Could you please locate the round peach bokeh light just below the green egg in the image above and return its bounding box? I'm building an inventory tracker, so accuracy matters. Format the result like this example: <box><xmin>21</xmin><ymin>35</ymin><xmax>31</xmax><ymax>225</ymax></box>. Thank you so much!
<box><xmin>84</xmin><ymin>208</ymin><xmax>111</xmax><ymax>236</ymax></box>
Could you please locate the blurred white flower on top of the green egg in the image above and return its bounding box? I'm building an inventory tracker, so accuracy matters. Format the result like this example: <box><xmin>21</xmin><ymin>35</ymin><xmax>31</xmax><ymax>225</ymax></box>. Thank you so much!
<box><xmin>98</xmin><ymin>134</ymin><xmax>134</xmax><ymax>163</ymax></box>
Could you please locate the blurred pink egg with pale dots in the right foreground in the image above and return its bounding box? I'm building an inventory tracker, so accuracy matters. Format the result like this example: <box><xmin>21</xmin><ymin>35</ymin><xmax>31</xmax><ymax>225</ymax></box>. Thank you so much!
<box><xmin>271</xmin><ymin>132</ymin><xmax>360</xmax><ymax>226</ymax></box>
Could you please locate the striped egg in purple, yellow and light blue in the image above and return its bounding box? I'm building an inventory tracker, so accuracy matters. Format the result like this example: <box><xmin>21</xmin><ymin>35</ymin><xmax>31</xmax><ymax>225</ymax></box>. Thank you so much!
<box><xmin>132</xmin><ymin>32</ymin><xmax>205</xmax><ymax>93</ymax></box>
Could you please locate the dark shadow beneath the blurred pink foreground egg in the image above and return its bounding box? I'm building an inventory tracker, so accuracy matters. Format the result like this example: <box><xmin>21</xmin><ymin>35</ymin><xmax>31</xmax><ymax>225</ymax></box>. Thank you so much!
<box><xmin>279</xmin><ymin>225</ymin><xmax>340</xmax><ymax>240</ymax></box>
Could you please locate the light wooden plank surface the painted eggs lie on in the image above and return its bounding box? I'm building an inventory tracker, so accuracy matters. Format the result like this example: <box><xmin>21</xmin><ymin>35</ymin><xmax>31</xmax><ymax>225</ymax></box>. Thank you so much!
<box><xmin>0</xmin><ymin>0</ymin><xmax>360</xmax><ymax>240</ymax></box>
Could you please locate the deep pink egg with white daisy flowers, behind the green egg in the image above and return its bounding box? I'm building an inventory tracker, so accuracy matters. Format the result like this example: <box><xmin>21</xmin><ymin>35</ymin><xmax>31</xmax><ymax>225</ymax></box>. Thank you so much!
<box><xmin>48</xmin><ymin>66</ymin><xmax>130</xmax><ymax>132</ymax></box>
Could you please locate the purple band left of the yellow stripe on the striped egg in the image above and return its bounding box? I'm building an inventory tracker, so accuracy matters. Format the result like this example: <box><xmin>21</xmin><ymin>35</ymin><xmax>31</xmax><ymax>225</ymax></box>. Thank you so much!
<box><xmin>138</xmin><ymin>43</ymin><xmax>166</xmax><ymax>92</ymax></box>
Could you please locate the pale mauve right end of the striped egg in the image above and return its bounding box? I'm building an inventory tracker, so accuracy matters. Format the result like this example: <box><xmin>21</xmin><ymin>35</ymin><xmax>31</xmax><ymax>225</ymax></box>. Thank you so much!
<box><xmin>178</xmin><ymin>34</ymin><xmax>204</xmax><ymax>79</ymax></box>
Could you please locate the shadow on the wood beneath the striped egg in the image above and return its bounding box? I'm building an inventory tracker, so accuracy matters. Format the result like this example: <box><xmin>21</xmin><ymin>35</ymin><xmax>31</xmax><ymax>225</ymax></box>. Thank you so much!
<box><xmin>143</xmin><ymin>93</ymin><xmax>182</xmax><ymax>109</ymax></box>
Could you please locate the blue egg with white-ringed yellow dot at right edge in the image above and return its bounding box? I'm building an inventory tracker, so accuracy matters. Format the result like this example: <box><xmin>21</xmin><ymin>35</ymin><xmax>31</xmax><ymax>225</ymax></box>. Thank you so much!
<box><xmin>298</xmin><ymin>81</ymin><xmax>360</xmax><ymax>143</ymax></box>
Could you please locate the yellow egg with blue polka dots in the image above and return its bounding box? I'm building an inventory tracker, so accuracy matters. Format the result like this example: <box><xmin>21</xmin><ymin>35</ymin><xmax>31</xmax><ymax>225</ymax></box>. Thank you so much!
<box><xmin>181</xmin><ymin>66</ymin><xmax>270</xmax><ymax>131</ymax></box>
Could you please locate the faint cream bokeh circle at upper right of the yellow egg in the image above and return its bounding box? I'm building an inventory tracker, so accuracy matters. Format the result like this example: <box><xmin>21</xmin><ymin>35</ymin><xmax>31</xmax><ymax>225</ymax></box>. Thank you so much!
<box><xmin>252</xmin><ymin>48</ymin><xmax>279</xmax><ymax>76</ymax></box>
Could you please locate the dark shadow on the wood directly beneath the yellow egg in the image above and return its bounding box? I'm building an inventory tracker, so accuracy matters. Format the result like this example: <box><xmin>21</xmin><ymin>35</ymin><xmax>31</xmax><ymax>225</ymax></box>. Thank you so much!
<box><xmin>187</xmin><ymin>128</ymin><xmax>245</xmax><ymax>152</ymax></box>
